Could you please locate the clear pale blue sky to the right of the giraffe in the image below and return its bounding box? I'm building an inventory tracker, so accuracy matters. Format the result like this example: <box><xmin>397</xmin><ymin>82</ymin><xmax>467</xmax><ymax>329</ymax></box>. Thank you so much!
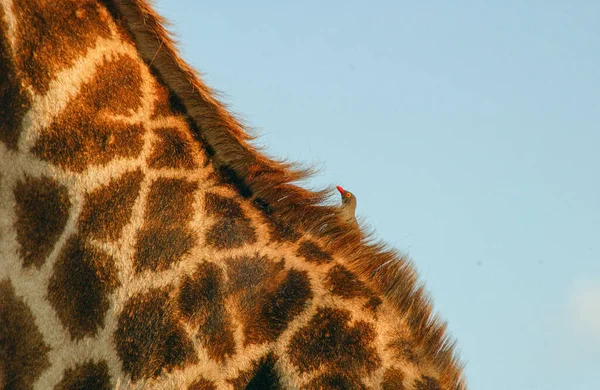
<box><xmin>156</xmin><ymin>0</ymin><xmax>600</xmax><ymax>390</ymax></box>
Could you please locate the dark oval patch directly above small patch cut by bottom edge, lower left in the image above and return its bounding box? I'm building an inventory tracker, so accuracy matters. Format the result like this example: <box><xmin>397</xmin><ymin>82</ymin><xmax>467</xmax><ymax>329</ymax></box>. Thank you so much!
<box><xmin>48</xmin><ymin>236</ymin><xmax>119</xmax><ymax>340</ymax></box>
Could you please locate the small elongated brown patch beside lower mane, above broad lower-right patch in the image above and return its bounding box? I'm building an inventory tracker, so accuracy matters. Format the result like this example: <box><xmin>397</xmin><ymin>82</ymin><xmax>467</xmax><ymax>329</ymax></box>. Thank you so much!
<box><xmin>325</xmin><ymin>264</ymin><xmax>382</xmax><ymax>311</ymax></box>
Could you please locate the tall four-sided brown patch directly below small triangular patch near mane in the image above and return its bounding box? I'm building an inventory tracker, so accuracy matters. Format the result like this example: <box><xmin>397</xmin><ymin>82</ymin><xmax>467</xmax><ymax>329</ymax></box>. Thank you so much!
<box><xmin>133</xmin><ymin>178</ymin><xmax>198</xmax><ymax>272</ymax></box>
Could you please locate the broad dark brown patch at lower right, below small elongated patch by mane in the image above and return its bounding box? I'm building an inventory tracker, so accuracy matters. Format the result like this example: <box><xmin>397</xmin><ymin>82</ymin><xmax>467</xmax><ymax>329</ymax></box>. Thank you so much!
<box><xmin>287</xmin><ymin>307</ymin><xmax>381</xmax><ymax>375</ymax></box>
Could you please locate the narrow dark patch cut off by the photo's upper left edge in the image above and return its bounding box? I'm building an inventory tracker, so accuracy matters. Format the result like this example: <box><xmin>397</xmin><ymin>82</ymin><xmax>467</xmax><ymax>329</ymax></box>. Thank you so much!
<box><xmin>0</xmin><ymin>8</ymin><xmax>31</xmax><ymax>150</ymax></box>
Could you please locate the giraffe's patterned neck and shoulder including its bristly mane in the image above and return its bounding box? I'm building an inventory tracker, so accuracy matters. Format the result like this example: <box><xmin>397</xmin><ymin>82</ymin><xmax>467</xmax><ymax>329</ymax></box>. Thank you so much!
<box><xmin>0</xmin><ymin>0</ymin><xmax>466</xmax><ymax>390</ymax></box>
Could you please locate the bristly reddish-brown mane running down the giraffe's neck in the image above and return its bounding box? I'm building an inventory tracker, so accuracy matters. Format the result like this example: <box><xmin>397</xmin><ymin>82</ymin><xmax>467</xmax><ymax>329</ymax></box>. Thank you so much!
<box><xmin>103</xmin><ymin>0</ymin><xmax>466</xmax><ymax>389</ymax></box>
